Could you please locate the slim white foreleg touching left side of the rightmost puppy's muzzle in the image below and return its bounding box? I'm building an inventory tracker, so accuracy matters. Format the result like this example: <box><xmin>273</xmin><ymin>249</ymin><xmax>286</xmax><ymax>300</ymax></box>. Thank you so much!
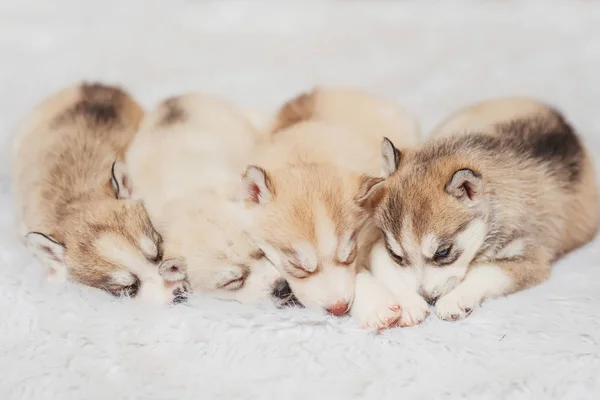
<box><xmin>370</xmin><ymin>241</ymin><xmax>429</xmax><ymax>326</ymax></box>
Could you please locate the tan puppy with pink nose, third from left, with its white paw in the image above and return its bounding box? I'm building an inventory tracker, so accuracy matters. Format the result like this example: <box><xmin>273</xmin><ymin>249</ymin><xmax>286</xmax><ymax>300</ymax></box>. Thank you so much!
<box><xmin>236</xmin><ymin>87</ymin><xmax>419</xmax><ymax>328</ymax></box>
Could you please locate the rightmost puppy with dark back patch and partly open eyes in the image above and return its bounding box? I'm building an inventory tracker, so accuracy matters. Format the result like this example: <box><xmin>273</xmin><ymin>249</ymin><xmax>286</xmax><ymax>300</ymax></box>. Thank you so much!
<box><xmin>376</xmin><ymin>98</ymin><xmax>599</xmax><ymax>320</ymax></box>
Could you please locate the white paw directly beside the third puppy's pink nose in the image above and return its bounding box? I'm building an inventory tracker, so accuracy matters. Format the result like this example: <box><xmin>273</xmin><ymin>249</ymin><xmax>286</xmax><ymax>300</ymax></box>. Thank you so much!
<box><xmin>350</xmin><ymin>268</ymin><xmax>401</xmax><ymax>331</ymax></box>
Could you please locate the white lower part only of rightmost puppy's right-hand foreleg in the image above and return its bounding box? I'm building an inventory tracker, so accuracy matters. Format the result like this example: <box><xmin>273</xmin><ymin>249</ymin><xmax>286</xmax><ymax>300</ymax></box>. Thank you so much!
<box><xmin>435</xmin><ymin>264</ymin><xmax>513</xmax><ymax>319</ymax></box>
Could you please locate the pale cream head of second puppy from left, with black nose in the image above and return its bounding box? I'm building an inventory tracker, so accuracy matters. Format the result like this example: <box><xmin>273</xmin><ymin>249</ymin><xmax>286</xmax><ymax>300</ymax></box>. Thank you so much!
<box><xmin>161</xmin><ymin>193</ymin><xmax>297</xmax><ymax>307</ymax></box>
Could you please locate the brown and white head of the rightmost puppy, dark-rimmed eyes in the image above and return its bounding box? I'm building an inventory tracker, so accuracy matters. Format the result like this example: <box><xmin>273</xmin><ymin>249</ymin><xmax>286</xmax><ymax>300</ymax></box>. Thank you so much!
<box><xmin>375</xmin><ymin>140</ymin><xmax>489</xmax><ymax>300</ymax></box>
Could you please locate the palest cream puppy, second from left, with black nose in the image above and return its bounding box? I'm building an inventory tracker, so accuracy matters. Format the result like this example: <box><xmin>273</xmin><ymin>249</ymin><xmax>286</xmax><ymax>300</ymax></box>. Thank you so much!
<box><xmin>126</xmin><ymin>94</ymin><xmax>295</xmax><ymax>305</ymax></box>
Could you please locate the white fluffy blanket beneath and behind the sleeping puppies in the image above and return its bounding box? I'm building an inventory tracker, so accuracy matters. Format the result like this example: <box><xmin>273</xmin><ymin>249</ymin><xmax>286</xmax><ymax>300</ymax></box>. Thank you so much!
<box><xmin>0</xmin><ymin>0</ymin><xmax>600</xmax><ymax>400</ymax></box>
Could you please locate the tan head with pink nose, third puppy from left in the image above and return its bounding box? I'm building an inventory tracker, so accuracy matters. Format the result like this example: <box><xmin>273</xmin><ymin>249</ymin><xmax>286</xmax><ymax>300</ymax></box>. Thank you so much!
<box><xmin>240</xmin><ymin>164</ymin><xmax>383</xmax><ymax>315</ymax></box>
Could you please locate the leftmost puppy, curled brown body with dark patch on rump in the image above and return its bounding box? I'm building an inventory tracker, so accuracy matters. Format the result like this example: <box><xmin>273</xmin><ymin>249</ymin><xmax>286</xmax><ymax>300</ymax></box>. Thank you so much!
<box><xmin>13</xmin><ymin>84</ymin><xmax>186</xmax><ymax>304</ymax></box>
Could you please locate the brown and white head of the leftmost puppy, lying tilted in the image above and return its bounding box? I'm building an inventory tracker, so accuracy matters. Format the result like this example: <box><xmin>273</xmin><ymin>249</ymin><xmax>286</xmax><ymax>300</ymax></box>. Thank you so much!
<box><xmin>25</xmin><ymin>161</ymin><xmax>187</xmax><ymax>304</ymax></box>
